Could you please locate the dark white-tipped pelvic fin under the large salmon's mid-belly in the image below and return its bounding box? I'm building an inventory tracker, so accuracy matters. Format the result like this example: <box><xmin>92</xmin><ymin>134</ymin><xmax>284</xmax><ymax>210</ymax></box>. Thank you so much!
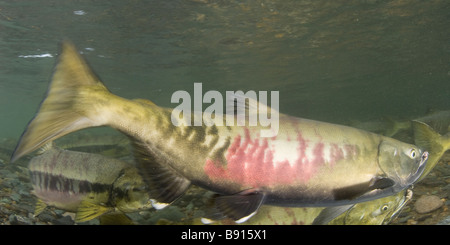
<box><xmin>215</xmin><ymin>190</ymin><xmax>265</xmax><ymax>223</ymax></box>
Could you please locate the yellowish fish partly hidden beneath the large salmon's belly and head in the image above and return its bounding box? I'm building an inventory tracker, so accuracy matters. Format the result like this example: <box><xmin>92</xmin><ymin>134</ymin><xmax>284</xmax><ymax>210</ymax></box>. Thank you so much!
<box><xmin>168</xmin><ymin>189</ymin><xmax>413</xmax><ymax>225</ymax></box>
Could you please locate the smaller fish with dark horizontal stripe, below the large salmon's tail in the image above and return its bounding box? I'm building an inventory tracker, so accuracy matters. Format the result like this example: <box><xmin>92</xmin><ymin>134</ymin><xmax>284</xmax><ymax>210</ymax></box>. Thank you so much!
<box><xmin>28</xmin><ymin>147</ymin><xmax>152</xmax><ymax>222</ymax></box>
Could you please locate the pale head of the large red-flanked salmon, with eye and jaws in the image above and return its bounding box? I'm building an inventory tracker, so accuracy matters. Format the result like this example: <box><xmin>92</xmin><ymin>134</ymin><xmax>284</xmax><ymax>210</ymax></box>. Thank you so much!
<box><xmin>378</xmin><ymin>140</ymin><xmax>428</xmax><ymax>188</ymax></box>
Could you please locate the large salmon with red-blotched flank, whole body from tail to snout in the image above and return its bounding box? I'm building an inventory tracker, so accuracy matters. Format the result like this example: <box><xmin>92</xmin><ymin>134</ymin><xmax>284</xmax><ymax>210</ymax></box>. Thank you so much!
<box><xmin>12</xmin><ymin>42</ymin><xmax>428</xmax><ymax>220</ymax></box>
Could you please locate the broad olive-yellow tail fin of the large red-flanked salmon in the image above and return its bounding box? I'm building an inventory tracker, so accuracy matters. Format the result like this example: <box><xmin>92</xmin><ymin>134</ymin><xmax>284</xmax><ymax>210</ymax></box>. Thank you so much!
<box><xmin>11</xmin><ymin>41</ymin><xmax>108</xmax><ymax>162</ymax></box>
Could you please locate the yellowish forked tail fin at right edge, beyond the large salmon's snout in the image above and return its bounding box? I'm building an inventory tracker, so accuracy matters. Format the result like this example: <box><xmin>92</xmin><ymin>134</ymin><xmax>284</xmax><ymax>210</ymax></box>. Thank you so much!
<box><xmin>412</xmin><ymin>121</ymin><xmax>450</xmax><ymax>180</ymax></box>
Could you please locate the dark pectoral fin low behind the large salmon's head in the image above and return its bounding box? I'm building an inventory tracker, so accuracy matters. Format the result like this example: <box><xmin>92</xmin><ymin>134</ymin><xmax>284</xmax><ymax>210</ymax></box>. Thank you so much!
<box><xmin>333</xmin><ymin>177</ymin><xmax>395</xmax><ymax>200</ymax></box>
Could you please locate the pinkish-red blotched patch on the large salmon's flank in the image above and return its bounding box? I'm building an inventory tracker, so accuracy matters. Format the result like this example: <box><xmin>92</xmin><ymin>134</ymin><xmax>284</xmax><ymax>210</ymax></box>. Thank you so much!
<box><xmin>204</xmin><ymin>129</ymin><xmax>355</xmax><ymax>187</ymax></box>
